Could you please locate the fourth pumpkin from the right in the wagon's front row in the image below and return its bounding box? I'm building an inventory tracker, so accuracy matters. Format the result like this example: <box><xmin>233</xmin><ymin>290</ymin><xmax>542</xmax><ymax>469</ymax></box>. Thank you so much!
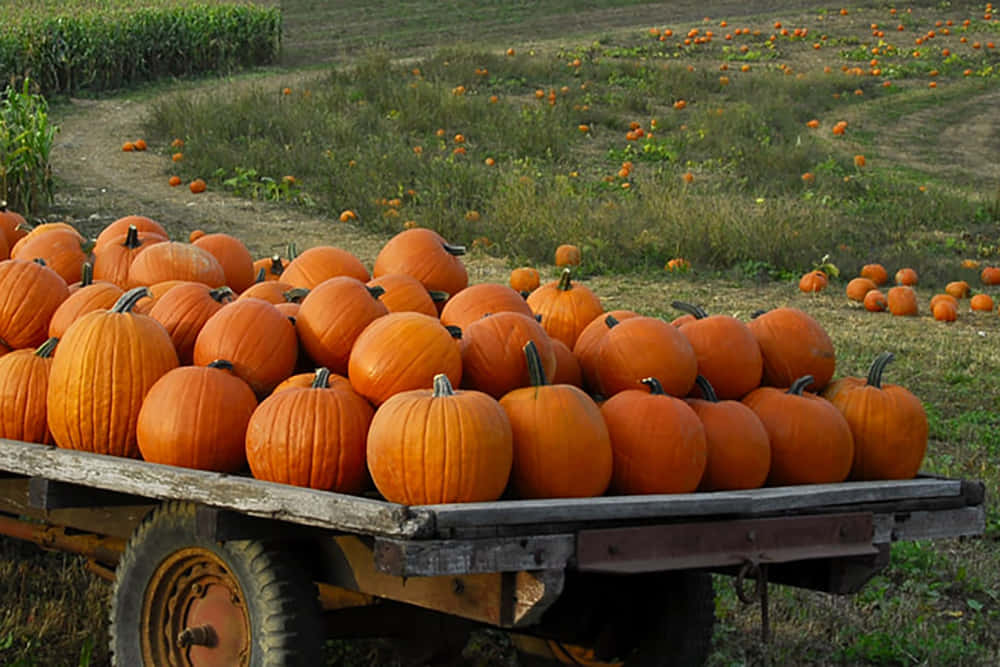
<box><xmin>601</xmin><ymin>378</ymin><xmax>708</xmax><ymax>494</ymax></box>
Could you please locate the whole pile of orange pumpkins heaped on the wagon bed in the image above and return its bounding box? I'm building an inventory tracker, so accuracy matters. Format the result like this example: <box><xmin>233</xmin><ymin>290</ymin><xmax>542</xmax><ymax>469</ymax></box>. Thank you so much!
<box><xmin>0</xmin><ymin>209</ymin><xmax>927</xmax><ymax>505</ymax></box>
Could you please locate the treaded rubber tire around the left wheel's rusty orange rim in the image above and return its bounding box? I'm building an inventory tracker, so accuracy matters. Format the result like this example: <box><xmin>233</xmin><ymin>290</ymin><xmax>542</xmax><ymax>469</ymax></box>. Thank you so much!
<box><xmin>110</xmin><ymin>502</ymin><xmax>325</xmax><ymax>667</ymax></box>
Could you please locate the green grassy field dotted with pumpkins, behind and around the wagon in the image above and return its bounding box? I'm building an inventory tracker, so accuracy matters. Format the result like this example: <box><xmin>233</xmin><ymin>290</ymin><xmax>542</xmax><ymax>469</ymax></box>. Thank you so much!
<box><xmin>0</xmin><ymin>0</ymin><xmax>1000</xmax><ymax>666</ymax></box>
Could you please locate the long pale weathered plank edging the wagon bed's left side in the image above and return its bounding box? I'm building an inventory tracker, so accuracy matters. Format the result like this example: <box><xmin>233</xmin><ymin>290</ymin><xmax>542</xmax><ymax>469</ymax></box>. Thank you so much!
<box><xmin>0</xmin><ymin>439</ymin><xmax>433</xmax><ymax>537</ymax></box>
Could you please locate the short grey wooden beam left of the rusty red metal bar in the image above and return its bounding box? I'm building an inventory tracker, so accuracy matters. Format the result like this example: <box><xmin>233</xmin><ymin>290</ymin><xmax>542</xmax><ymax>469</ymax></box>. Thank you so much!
<box><xmin>375</xmin><ymin>535</ymin><xmax>576</xmax><ymax>577</ymax></box>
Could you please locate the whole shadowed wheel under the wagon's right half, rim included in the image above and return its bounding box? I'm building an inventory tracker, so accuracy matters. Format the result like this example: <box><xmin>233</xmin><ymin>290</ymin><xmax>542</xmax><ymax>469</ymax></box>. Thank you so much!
<box><xmin>512</xmin><ymin>572</ymin><xmax>715</xmax><ymax>667</ymax></box>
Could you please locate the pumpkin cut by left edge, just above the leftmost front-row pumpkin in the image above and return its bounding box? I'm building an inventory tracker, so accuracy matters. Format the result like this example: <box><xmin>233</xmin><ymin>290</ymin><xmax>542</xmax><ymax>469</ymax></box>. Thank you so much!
<box><xmin>0</xmin><ymin>259</ymin><xmax>69</xmax><ymax>349</ymax></box>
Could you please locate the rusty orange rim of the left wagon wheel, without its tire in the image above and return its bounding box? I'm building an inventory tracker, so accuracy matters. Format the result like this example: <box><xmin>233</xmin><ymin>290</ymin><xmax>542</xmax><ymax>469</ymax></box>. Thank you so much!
<box><xmin>141</xmin><ymin>547</ymin><xmax>250</xmax><ymax>667</ymax></box>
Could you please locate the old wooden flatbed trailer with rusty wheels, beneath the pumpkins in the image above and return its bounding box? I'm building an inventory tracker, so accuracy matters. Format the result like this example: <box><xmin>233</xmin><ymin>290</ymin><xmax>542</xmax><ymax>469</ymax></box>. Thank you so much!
<box><xmin>0</xmin><ymin>439</ymin><xmax>985</xmax><ymax>667</ymax></box>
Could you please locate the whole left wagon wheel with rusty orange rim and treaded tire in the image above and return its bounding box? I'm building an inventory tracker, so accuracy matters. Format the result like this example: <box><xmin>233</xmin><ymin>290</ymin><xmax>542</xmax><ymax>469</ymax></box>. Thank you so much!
<box><xmin>111</xmin><ymin>503</ymin><xmax>323</xmax><ymax>667</ymax></box>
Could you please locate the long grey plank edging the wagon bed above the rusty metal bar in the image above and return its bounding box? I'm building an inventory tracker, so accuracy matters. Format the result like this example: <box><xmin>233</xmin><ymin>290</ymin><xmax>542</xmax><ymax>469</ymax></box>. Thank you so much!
<box><xmin>416</xmin><ymin>478</ymin><xmax>962</xmax><ymax>531</ymax></box>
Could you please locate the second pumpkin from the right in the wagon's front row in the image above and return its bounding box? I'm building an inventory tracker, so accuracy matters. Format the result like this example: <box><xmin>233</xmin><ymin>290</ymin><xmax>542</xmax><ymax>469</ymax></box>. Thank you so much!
<box><xmin>743</xmin><ymin>375</ymin><xmax>854</xmax><ymax>486</ymax></box>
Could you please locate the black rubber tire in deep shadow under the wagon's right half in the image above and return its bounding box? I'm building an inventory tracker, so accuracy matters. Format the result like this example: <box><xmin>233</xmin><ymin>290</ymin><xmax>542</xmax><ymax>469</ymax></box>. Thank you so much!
<box><xmin>519</xmin><ymin>571</ymin><xmax>715</xmax><ymax>667</ymax></box>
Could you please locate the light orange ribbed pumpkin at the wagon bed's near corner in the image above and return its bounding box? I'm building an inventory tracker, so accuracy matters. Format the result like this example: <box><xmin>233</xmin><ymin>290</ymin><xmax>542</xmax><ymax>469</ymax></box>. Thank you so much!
<box><xmin>367</xmin><ymin>373</ymin><xmax>513</xmax><ymax>505</ymax></box>
